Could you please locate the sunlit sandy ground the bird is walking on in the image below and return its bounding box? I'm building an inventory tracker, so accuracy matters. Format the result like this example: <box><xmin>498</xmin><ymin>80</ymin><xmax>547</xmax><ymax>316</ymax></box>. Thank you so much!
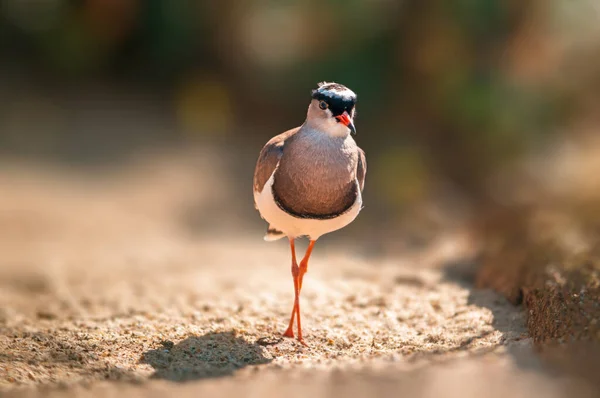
<box><xmin>0</xmin><ymin>154</ymin><xmax>593</xmax><ymax>397</ymax></box>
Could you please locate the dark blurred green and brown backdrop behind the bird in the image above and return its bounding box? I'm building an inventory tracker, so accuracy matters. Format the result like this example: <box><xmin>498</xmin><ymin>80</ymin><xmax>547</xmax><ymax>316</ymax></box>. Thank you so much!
<box><xmin>0</xmin><ymin>0</ymin><xmax>600</xmax><ymax>249</ymax></box>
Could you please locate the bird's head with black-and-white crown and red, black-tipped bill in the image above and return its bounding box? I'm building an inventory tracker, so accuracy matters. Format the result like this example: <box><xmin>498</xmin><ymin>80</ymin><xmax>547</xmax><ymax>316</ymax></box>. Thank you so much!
<box><xmin>306</xmin><ymin>82</ymin><xmax>356</xmax><ymax>137</ymax></box>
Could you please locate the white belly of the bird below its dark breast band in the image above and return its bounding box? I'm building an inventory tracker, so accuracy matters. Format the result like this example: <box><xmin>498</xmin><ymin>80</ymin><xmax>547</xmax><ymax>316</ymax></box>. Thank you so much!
<box><xmin>254</xmin><ymin>173</ymin><xmax>362</xmax><ymax>240</ymax></box>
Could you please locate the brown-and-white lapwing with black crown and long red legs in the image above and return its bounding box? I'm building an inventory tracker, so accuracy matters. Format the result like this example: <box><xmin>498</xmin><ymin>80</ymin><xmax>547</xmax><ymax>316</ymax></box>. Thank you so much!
<box><xmin>253</xmin><ymin>82</ymin><xmax>367</xmax><ymax>345</ymax></box>
